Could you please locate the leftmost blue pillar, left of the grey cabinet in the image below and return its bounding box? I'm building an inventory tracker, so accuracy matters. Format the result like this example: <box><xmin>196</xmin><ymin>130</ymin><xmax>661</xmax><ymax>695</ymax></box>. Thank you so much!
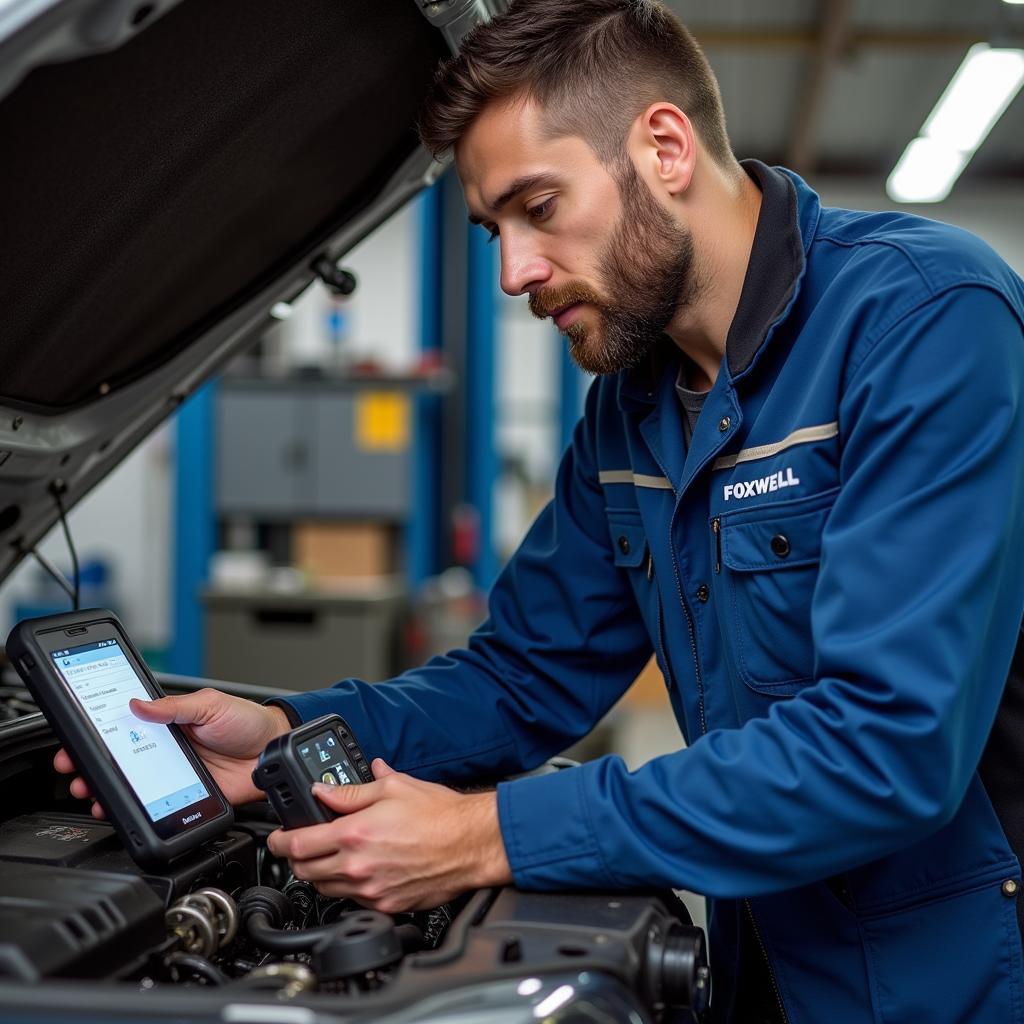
<box><xmin>168</xmin><ymin>382</ymin><xmax>216</xmax><ymax>676</ymax></box>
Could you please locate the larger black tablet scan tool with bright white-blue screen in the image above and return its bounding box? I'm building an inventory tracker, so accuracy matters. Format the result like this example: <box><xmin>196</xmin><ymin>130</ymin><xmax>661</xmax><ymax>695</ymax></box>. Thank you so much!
<box><xmin>7</xmin><ymin>608</ymin><xmax>233</xmax><ymax>867</ymax></box>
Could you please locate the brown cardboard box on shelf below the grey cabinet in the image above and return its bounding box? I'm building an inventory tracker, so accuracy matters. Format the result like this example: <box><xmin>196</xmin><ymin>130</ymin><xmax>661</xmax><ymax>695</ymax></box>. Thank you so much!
<box><xmin>292</xmin><ymin>522</ymin><xmax>395</xmax><ymax>581</ymax></box>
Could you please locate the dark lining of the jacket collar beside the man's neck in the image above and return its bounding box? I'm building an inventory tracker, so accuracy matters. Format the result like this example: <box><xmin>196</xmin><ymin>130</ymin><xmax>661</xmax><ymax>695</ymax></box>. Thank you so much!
<box><xmin>725</xmin><ymin>160</ymin><xmax>804</xmax><ymax>378</ymax></box>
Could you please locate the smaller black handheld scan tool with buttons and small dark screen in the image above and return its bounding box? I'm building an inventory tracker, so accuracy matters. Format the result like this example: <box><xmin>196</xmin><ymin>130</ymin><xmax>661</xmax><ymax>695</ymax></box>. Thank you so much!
<box><xmin>253</xmin><ymin>715</ymin><xmax>374</xmax><ymax>828</ymax></box>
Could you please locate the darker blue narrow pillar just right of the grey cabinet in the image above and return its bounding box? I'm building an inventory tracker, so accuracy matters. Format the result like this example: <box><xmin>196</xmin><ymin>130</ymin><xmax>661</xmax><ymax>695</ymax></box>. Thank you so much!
<box><xmin>406</xmin><ymin>181</ymin><xmax>444</xmax><ymax>589</ymax></box>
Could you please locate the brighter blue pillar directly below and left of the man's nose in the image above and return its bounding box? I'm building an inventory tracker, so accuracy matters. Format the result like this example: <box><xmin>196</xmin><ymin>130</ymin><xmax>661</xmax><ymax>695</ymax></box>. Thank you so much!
<box><xmin>464</xmin><ymin>225</ymin><xmax>499</xmax><ymax>590</ymax></box>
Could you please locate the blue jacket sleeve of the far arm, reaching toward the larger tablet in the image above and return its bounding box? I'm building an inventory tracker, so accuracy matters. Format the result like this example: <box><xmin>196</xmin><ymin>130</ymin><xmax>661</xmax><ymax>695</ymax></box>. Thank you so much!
<box><xmin>276</xmin><ymin>385</ymin><xmax>651</xmax><ymax>781</ymax></box>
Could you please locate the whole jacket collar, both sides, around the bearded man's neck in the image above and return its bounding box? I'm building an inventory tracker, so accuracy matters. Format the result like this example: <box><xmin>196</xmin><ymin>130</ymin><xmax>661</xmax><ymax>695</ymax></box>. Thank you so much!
<box><xmin>620</xmin><ymin>160</ymin><xmax>821</xmax><ymax>404</ymax></box>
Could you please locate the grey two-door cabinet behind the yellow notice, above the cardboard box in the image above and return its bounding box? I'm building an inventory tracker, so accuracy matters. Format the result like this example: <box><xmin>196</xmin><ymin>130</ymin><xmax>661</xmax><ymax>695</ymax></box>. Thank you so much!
<box><xmin>216</xmin><ymin>379</ymin><xmax>410</xmax><ymax>520</ymax></box>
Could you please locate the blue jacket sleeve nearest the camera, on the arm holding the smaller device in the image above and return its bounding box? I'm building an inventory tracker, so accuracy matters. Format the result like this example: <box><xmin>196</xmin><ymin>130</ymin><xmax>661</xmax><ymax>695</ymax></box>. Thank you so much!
<box><xmin>499</xmin><ymin>287</ymin><xmax>1024</xmax><ymax>897</ymax></box>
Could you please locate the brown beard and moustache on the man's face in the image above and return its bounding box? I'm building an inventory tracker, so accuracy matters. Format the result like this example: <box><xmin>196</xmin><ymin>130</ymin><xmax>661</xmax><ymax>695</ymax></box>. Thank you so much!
<box><xmin>529</xmin><ymin>157</ymin><xmax>700</xmax><ymax>376</ymax></box>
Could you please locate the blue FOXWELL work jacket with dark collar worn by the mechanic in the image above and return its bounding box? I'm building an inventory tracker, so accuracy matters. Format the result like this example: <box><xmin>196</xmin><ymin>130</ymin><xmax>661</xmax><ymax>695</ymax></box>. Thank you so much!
<box><xmin>282</xmin><ymin>162</ymin><xmax>1024</xmax><ymax>1024</ymax></box>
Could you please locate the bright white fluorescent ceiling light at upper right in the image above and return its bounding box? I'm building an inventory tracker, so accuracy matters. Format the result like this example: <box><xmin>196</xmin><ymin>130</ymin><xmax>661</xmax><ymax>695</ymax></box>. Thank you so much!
<box><xmin>886</xmin><ymin>43</ymin><xmax>1024</xmax><ymax>203</ymax></box>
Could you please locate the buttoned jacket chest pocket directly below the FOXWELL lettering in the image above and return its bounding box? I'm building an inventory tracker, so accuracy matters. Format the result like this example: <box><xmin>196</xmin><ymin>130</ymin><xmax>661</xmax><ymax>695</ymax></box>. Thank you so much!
<box><xmin>713</xmin><ymin>487</ymin><xmax>839</xmax><ymax>695</ymax></box>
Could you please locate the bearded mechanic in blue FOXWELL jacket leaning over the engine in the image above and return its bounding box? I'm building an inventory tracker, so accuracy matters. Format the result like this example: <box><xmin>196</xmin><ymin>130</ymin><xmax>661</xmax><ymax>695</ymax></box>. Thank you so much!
<box><xmin>56</xmin><ymin>0</ymin><xmax>1024</xmax><ymax>1024</ymax></box>
